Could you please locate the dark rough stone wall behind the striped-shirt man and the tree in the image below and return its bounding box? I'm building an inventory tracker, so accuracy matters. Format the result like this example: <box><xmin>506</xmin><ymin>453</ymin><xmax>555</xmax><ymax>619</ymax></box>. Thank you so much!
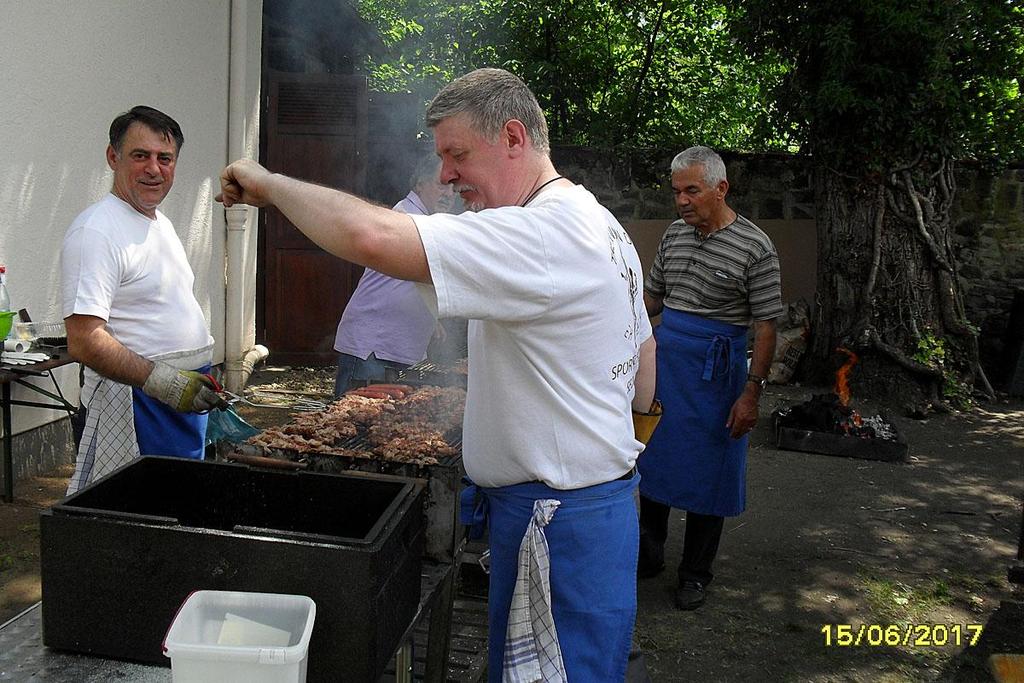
<box><xmin>552</xmin><ymin>147</ymin><xmax>1024</xmax><ymax>376</ymax></box>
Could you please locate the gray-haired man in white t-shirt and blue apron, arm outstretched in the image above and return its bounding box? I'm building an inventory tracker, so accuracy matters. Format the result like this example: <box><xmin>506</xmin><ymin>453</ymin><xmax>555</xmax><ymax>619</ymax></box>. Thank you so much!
<box><xmin>218</xmin><ymin>69</ymin><xmax>654</xmax><ymax>681</ymax></box>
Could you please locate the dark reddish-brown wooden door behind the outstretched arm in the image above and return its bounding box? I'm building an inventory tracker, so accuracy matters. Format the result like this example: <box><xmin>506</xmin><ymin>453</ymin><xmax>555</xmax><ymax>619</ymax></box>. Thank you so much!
<box><xmin>260</xmin><ymin>73</ymin><xmax>367</xmax><ymax>365</ymax></box>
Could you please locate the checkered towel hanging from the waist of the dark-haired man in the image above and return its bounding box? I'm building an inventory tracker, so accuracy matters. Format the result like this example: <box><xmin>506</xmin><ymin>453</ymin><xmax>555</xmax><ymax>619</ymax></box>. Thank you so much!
<box><xmin>68</xmin><ymin>377</ymin><xmax>139</xmax><ymax>496</ymax></box>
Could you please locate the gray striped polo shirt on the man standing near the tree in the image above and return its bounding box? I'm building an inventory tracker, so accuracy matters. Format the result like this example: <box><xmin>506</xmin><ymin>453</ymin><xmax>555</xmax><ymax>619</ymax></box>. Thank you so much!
<box><xmin>644</xmin><ymin>214</ymin><xmax>782</xmax><ymax>326</ymax></box>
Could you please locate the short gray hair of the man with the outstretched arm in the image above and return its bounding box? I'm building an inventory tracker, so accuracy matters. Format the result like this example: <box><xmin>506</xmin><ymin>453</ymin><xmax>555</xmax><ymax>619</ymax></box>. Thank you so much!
<box><xmin>426</xmin><ymin>69</ymin><xmax>551</xmax><ymax>154</ymax></box>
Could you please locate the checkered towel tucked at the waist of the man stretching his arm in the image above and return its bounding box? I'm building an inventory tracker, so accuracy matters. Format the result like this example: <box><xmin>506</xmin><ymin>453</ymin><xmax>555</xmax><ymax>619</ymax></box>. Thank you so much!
<box><xmin>502</xmin><ymin>499</ymin><xmax>566</xmax><ymax>683</ymax></box>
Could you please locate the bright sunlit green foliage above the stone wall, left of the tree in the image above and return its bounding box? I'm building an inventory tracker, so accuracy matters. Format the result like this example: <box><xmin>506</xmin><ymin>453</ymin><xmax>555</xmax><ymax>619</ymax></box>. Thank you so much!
<box><xmin>360</xmin><ymin>0</ymin><xmax>780</xmax><ymax>148</ymax></box>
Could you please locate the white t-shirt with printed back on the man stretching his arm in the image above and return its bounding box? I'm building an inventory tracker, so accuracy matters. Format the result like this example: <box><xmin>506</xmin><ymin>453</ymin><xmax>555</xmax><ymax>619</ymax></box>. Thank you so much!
<box><xmin>413</xmin><ymin>185</ymin><xmax>651</xmax><ymax>489</ymax></box>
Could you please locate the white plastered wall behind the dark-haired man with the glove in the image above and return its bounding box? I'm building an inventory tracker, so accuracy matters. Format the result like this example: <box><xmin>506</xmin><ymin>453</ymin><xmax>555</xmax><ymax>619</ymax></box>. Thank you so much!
<box><xmin>0</xmin><ymin>0</ymin><xmax>261</xmax><ymax>431</ymax></box>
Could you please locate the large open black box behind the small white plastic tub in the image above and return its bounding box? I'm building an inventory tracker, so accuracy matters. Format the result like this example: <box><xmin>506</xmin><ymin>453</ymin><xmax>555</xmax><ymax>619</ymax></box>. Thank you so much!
<box><xmin>40</xmin><ymin>458</ymin><xmax>424</xmax><ymax>682</ymax></box>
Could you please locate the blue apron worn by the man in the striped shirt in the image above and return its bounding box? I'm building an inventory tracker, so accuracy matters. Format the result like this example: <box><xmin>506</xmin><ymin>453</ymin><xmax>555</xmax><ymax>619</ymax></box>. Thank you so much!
<box><xmin>637</xmin><ymin>308</ymin><xmax>749</xmax><ymax>517</ymax></box>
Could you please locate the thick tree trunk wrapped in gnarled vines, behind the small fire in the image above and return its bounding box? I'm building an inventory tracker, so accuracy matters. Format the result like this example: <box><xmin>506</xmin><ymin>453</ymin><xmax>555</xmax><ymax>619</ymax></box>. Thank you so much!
<box><xmin>811</xmin><ymin>159</ymin><xmax>990</xmax><ymax>401</ymax></box>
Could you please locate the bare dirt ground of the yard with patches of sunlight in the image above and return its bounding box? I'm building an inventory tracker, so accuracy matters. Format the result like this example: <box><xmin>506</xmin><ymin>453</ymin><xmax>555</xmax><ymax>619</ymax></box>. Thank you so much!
<box><xmin>0</xmin><ymin>368</ymin><xmax>1024</xmax><ymax>683</ymax></box>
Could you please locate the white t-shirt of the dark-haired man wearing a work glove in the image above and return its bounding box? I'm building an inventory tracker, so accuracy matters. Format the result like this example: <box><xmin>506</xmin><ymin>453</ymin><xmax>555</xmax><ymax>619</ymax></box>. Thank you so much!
<box><xmin>60</xmin><ymin>195</ymin><xmax>213</xmax><ymax>358</ymax></box>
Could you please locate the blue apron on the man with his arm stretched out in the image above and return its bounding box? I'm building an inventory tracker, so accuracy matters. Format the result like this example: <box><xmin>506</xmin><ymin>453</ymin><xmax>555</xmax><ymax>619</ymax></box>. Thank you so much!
<box><xmin>462</xmin><ymin>476</ymin><xmax>639</xmax><ymax>682</ymax></box>
